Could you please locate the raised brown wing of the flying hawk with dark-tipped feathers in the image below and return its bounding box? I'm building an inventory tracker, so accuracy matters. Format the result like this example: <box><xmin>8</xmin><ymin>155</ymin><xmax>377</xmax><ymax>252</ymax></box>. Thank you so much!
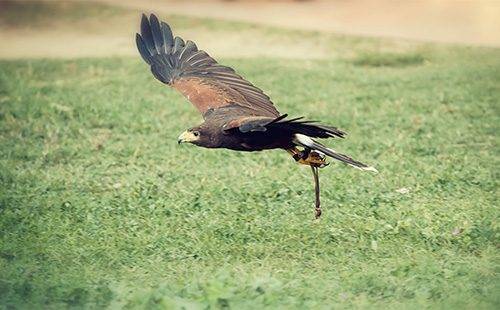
<box><xmin>136</xmin><ymin>14</ymin><xmax>279</xmax><ymax>117</ymax></box>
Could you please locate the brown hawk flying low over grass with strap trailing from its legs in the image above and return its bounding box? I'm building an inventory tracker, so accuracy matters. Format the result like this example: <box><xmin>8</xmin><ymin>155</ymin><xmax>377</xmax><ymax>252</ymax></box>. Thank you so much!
<box><xmin>136</xmin><ymin>14</ymin><xmax>376</xmax><ymax>218</ymax></box>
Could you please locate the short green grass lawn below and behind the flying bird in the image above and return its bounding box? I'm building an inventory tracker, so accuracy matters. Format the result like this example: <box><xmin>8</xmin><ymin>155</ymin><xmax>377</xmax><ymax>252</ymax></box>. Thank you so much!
<box><xmin>0</xmin><ymin>4</ymin><xmax>500</xmax><ymax>309</ymax></box>
